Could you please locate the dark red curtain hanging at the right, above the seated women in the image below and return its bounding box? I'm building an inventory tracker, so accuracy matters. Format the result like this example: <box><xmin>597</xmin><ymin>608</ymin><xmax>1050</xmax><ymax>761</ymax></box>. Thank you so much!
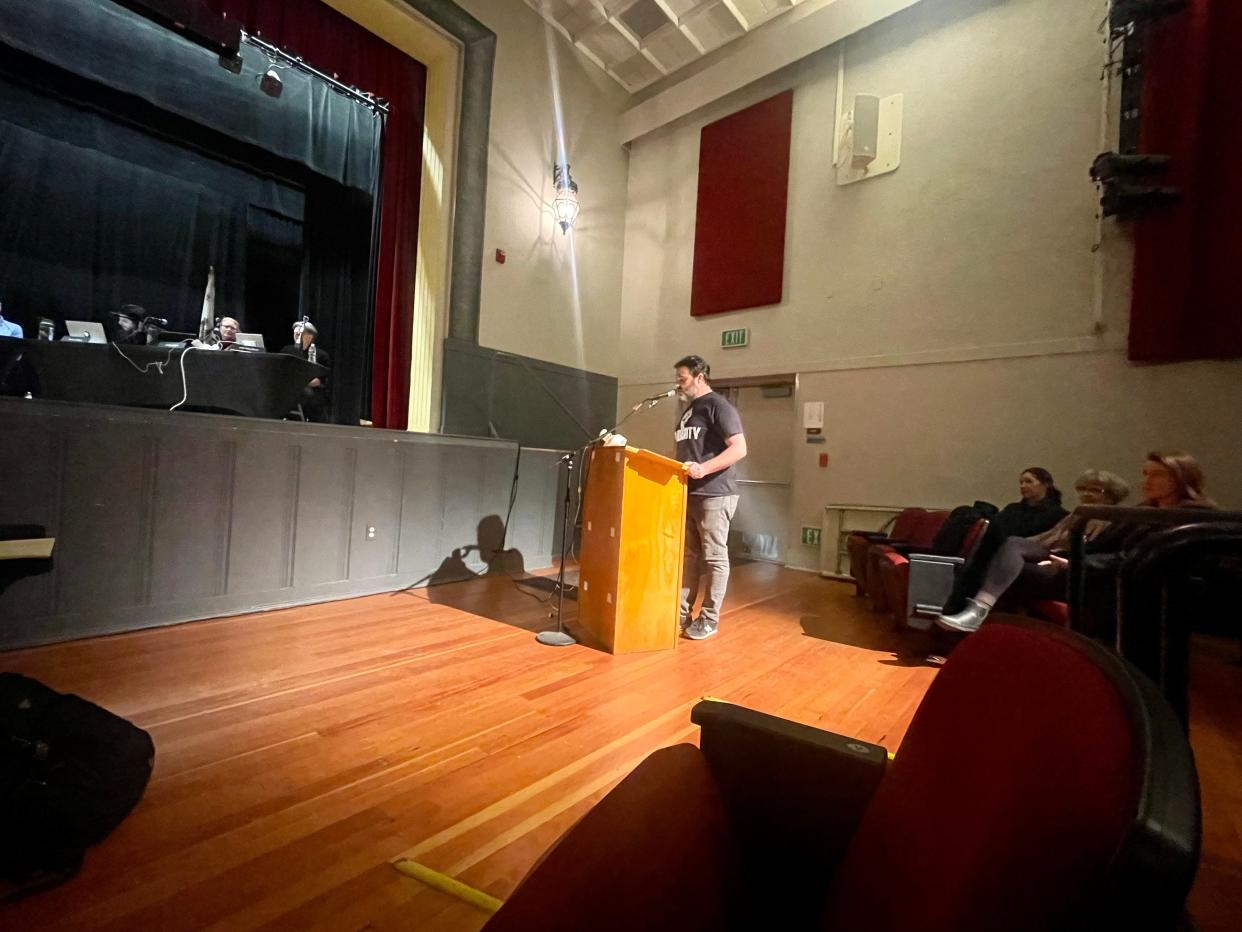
<box><xmin>1129</xmin><ymin>0</ymin><xmax>1242</xmax><ymax>362</ymax></box>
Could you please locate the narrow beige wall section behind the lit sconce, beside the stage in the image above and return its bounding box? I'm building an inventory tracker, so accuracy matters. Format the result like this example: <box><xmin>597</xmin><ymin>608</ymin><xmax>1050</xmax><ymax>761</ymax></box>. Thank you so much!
<box><xmin>457</xmin><ymin>0</ymin><xmax>628</xmax><ymax>375</ymax></box>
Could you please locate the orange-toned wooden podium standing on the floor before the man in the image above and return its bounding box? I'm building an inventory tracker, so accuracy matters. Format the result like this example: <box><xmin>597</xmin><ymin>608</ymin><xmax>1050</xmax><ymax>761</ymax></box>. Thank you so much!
<box><xmin>578</xmin><ymin>446</ymin><xmax>686</xmax><ymax>654</ymax></box>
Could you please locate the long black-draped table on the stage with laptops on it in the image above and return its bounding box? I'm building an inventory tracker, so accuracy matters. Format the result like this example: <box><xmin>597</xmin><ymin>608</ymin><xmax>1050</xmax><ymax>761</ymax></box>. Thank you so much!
<box><xmin>0</xmin><ymin>339</ymin><xmax>328</xmax><ymax>419</ymax></box>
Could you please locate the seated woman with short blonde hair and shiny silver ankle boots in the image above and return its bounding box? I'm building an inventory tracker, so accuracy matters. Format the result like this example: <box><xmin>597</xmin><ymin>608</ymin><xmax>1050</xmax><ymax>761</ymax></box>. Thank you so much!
<box><xmin>936</xmin><ymin>470</ymin><xmax>1130</xmax><ymax>631</ymax></box>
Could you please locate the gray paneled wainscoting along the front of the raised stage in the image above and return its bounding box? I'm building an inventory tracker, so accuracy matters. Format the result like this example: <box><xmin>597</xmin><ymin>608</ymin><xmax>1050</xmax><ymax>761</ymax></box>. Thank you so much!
<box><xmin>0</xmin><ymin>399</ymin><xmax>560</xmax><ymax>649</ymax></box>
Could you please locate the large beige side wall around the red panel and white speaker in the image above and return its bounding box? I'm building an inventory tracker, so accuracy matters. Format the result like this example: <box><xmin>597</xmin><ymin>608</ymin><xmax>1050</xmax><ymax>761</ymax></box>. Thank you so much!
<box><xmin>620</xmin><ymin>0</ymin><xmax>1242</xmax><ymax>567</ymax></box>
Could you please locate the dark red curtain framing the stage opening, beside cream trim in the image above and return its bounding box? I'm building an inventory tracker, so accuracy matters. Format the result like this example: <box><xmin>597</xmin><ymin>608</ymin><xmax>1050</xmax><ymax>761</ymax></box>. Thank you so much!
<box><xmin>206</xmin><ymin>0</ymin><xmax>427</xmax><ymax>430</ymax></box>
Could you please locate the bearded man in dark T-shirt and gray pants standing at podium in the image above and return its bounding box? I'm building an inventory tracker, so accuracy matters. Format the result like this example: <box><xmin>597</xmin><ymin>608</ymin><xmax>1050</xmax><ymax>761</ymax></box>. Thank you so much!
<box><xmin>673</xmin><ymin>355</ymin><xmax>746</xmax><ymax>641</ymax></box>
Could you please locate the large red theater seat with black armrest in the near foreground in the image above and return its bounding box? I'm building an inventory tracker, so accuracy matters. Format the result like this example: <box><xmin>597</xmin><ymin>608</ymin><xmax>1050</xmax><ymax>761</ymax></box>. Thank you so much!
<box><xmin>487</xmin><ymin>619</ymin><xmax>1200</xmax><ymax>932</ymax></box>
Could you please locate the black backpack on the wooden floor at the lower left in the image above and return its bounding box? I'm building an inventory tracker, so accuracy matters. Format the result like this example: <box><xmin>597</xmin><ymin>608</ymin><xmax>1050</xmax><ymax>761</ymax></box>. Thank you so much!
<box><xmin>0</xmin><ymin>674</ymin><xmax>155</xmax><ymax>902</ymax></box>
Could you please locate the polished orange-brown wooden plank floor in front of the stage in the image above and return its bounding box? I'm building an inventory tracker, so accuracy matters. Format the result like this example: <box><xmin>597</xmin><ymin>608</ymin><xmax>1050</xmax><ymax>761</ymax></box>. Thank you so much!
<box><xmin>0</xmin><ymin>563</ymin><xmax>1242</xmax><ymax>932</ymax></box>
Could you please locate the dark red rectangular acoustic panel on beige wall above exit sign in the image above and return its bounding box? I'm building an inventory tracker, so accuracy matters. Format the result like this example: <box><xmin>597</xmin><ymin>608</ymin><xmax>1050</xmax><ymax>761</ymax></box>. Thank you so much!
<box><xmin>691</xmin><ymin>91</ymin><xmax>794</xmax><ymax>317</ymax></box>
